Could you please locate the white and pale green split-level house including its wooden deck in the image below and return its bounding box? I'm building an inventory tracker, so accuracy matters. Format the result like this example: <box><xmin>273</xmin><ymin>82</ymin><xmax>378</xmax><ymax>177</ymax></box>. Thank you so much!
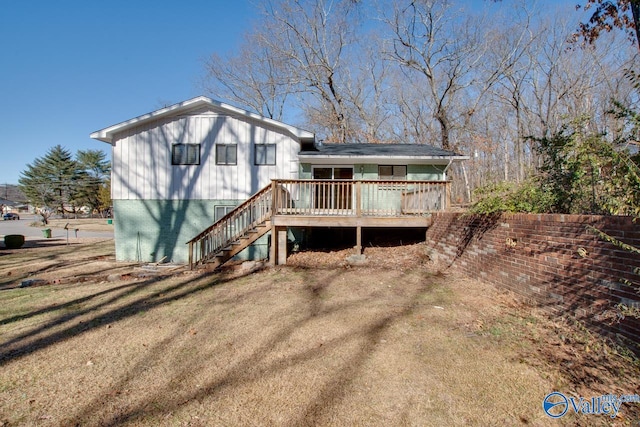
<box><xmin>91</xmin><ymin>97</ymin><xmax>465</xmax><ymax>265</ymax></box>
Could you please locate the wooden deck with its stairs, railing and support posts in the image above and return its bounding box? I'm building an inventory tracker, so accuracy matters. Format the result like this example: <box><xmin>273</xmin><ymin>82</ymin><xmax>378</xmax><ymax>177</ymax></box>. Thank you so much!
<box><xmin>188</xmin><ymin>180</ymin><xmax>450</xmax><ymax>268</ymax></box>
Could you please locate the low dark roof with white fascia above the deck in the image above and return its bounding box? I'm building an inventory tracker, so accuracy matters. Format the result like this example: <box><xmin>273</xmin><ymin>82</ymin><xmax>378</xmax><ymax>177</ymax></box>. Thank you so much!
<box><xmin>298</xmin><ymin>144</ymin><xmax>469</xmax><ymax>162</ymax></box>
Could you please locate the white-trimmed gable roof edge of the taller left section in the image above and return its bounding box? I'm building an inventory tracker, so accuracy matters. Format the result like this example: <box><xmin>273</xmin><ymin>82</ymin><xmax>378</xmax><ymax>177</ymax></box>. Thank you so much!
<box><xmin>89</xmin><ymin>96</ymin><xmax>315</xmax><ymax>144</ymax></box>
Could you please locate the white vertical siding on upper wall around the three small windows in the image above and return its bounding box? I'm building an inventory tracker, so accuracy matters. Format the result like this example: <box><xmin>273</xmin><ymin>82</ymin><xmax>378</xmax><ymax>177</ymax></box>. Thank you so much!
<box><xmin>112</xmin><ymin>110</ymin><xmax>300</xmax><ymax>200</ymax></box>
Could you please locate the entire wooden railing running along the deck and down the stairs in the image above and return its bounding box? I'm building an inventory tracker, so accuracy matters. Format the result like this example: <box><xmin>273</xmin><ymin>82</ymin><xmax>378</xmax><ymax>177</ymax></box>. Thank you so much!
<box><xmin>187</xmin><ymin>179</ymin><xmax>450</xmax><ymax>268</ymax></box>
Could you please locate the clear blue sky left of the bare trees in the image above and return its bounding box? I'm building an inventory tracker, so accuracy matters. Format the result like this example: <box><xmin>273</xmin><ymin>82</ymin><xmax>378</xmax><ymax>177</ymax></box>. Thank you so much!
<box><xmin>0</xmin><ymin>0</ymin><xmax>255</xmax><ymax>187</ymax></box>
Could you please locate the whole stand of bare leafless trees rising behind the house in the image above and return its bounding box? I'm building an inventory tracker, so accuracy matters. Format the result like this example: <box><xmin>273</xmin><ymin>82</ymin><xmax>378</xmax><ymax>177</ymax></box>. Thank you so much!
<box><xmin>198</xmin><ymin>0</ymin><xmax>638</xmax><ymax>204</ymax></box>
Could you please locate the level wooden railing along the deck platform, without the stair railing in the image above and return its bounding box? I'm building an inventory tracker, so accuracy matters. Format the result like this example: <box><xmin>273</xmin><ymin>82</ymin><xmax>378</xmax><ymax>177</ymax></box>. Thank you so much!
<box><xmin>273</xmin><ymin>179</ymin><xmax>450</xmax><ymax>216</ymax></box>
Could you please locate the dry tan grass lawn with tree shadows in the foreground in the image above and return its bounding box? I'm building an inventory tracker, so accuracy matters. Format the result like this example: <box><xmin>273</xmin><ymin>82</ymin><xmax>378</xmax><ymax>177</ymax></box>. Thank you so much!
<box><xmin>0</xmin><ymin>245</ymin><xmax>640</xmax><ymax>426</ymax></box>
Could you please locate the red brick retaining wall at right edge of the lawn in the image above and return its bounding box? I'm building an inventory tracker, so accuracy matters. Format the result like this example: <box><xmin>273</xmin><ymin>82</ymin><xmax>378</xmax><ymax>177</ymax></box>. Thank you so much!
<box><xmin>426</xmin><ymin>212</ymin><xmax>640</xmax><ymax>354</ymax></box>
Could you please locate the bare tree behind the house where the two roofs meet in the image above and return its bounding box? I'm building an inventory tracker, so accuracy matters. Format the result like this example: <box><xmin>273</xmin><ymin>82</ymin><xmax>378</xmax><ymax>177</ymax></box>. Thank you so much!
<box><xmin>264</xmin><ymin>0</ymin><xmax>358</xmax><ymax>142</ymax></box>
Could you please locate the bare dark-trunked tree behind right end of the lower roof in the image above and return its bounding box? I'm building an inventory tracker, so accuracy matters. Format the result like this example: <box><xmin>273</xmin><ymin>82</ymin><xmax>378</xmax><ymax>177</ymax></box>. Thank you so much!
<box><xmin>383</xmin><ymin>0</ymin><xmax>496</xmax><ymax>149</ymax></box>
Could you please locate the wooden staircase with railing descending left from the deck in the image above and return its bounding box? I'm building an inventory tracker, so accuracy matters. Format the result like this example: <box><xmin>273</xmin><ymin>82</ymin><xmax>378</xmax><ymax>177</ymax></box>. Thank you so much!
<box><xmin>187</xmin><ymin>185</ymin><xmax>273</xmax><ymax>269</ymax></box>
